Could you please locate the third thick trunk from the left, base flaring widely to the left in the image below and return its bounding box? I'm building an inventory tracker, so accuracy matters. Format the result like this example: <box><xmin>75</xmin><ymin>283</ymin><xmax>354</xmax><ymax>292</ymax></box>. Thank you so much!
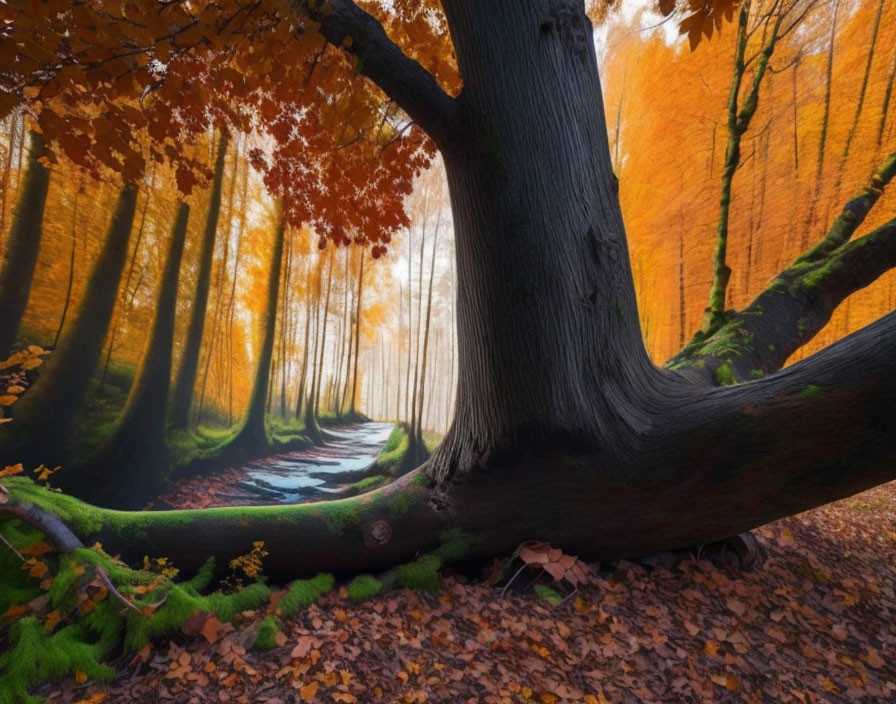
<box><xmin>71</xmin><ymin>202</ymin><xmax>190</xmax><ymax>508</ymax></box>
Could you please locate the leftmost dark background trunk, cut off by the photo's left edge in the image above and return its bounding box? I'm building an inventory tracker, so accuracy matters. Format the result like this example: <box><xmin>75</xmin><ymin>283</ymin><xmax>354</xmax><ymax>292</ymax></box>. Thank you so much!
<box><xmin>0</xmin><ymin>132</ymin><xmax>50</xmax><ymax>359</ymax></box>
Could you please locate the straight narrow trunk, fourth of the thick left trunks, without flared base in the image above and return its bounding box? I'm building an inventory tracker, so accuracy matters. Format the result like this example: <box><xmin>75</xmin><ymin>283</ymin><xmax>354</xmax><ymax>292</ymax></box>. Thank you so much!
<box><xmin>171</xmin><ymin>132</ymin><xmax>227</xmax><ymax>429</ymax></box>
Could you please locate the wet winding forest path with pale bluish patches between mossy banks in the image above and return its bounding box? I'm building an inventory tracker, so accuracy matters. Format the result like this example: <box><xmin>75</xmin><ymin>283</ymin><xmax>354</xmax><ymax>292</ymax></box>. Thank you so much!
<box><xmin>158</xmin><ymin>422</ymin><xmax>394</xmax><ymax>508</ymax></box>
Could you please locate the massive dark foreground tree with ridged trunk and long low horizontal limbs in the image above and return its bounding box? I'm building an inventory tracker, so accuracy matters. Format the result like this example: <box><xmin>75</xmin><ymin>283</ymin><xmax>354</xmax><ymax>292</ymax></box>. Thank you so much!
<box><xmin>0</xmin><ymin>0</ymin><xmax>896</xmax><ymax>578</ymax></box>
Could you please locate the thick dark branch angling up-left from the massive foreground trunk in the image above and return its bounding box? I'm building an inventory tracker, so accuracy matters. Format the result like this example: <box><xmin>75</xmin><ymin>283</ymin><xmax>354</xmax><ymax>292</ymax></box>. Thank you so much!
<box><xmin>293</xmin><ymin>0</ymin><xmax>457</xmax><ymax>145</ymax></box>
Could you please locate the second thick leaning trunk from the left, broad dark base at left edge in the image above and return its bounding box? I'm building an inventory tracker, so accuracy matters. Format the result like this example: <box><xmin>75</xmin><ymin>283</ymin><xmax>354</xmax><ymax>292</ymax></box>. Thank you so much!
<box><xmin>4</xmin><ymin>185</ymin><xmax>137</xmax><ymax>466</ymax></box>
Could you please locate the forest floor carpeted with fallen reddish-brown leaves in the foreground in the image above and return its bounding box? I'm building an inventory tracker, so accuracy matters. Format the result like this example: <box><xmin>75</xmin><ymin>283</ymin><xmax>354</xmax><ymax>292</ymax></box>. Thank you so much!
<box><xmin>43</xmin><ymin>483</ymin><xmax>896</xmax><ymax>704</ymax></box>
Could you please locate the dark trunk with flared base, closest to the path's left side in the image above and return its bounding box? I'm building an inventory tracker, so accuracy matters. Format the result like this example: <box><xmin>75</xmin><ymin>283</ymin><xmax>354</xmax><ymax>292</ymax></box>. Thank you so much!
<box><xmin>232</xmin><ymin>202</ymin><xmax>286</xmax><ymax>454</ymax></box>
